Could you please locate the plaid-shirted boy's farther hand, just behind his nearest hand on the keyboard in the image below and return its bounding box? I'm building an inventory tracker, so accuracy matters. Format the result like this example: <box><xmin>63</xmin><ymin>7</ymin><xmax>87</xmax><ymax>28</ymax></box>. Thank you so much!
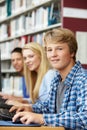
<box><xmin>9</xmin><ymin>105</ymin><xmax>32</xmax><ymax>113</ymax></box>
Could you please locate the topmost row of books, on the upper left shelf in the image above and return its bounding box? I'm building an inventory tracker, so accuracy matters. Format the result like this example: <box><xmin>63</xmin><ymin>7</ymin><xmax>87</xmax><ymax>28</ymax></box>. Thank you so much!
<box><xmin>0</xmin><ymin>0</ymin><xmax>47</xmax><ymax>20</ymax></box>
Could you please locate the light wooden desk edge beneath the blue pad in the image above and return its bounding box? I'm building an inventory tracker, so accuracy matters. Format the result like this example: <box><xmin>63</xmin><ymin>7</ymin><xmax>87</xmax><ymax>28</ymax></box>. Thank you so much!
<box><xmin>0</xmin><ymin>126</ymin><xmax>65</xmax><ymax>130</ymax></box>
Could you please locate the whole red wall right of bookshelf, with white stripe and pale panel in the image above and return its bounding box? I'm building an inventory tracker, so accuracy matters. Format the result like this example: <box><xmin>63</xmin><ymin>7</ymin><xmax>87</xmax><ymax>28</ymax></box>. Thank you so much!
<box><xmin>62</xmin><ymin>0</ymin><xmax>87</xmax><ymax>69</ymax></box>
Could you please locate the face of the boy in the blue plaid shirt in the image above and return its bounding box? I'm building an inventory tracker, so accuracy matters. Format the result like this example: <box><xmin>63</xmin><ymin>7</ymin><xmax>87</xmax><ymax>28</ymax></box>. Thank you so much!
<box><xmin>46</xmin><ymin>43</ymin><xmax>74</xmax><ymax>72</ymax></box>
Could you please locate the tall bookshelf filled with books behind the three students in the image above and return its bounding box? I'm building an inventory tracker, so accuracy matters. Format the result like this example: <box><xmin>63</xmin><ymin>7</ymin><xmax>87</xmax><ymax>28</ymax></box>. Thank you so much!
<box><xmin>0</xmin><ymin>0</ymin><xmax>61</xmax><ymax>93</ymax></box>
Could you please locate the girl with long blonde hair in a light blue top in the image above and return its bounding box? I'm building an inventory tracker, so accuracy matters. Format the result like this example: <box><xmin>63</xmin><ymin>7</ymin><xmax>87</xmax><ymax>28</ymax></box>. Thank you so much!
<box><xmin>1</xmin><ymin>42</ymin><xmax>57</xmax><ymax>106</ymax></box>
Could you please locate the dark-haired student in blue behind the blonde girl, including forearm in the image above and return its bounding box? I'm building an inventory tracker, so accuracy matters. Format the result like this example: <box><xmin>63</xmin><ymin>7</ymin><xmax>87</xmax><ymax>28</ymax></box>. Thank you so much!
<box><xmin>0</xmin><ymin>47</ymin><xmax>29</xmax><ymax>101</ymax></box>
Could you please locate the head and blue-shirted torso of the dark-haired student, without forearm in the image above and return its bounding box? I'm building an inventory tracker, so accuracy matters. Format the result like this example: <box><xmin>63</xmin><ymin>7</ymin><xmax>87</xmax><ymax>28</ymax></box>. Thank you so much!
<box><xmin>11</xmin><ymin>47</ymin><xmax>29</xmax><ymax>98</ymax></box>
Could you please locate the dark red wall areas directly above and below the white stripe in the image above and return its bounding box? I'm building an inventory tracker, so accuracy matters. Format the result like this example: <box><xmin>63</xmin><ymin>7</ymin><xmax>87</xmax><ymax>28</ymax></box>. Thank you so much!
<box><xmin>63</xmin><ymin>0</ymin><xmax>87</xmax><ymax>32</ymax></box>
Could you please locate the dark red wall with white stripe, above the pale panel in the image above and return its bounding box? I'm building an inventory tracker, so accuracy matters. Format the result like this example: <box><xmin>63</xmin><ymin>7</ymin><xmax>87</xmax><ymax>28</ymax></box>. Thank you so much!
<box><xmin>63</xmin><ymin>0</ymin><xmax>87</xmax><ymax>32</ymax></box>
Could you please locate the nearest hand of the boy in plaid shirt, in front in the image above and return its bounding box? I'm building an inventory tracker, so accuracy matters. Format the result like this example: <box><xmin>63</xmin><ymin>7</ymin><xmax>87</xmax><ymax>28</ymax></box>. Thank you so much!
<box><xmin>12</xmin><ymin>112</ymin><xmax>44</xmax><ymax>125</ymax></box>
